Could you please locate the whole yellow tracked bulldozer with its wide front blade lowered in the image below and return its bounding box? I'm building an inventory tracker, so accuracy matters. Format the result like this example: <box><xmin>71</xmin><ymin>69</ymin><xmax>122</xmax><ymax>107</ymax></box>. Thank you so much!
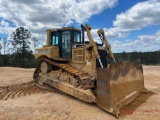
<box><xmin>33</xmin><ymin>24</ymin><xmax>146</xmax><ymax>117</ymax></box>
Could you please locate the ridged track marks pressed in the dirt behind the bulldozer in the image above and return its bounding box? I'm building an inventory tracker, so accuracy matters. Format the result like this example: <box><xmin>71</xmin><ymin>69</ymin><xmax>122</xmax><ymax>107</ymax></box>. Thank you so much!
<box><xmin>0</xmin><ymin>81</ymin><xmax>51</xmax><ymax>100</ymax></box>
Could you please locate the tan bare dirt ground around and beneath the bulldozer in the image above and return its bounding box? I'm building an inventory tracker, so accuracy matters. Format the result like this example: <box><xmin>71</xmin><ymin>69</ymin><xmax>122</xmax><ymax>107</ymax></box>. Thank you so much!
<box><xmin>0</xmin><ymin>66</ymin><xmax>160</xmax><ymax>120</ymax></box>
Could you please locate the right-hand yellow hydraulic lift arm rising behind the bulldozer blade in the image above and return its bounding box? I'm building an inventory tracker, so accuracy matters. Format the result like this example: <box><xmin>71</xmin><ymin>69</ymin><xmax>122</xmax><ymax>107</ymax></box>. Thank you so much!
<box><xmin>97</xmin><ymin>29</ymin><xmax>115</xmax><ymax>62</ymax></box>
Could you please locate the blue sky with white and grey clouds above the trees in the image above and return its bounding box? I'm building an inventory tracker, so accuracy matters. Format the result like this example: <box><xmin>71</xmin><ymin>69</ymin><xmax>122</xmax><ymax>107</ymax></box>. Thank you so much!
<box><xmin>0</xmin><ymin>0</ymin><xmax>160</xmax><ymax>53</ymax></box>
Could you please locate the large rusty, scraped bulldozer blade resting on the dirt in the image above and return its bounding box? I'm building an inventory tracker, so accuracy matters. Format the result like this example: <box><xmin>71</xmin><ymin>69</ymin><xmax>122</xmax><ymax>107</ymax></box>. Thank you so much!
<box><xmin>96</xmin><ymin>60</ymin><xmax>147</xmax><ymax>117</ymax></box>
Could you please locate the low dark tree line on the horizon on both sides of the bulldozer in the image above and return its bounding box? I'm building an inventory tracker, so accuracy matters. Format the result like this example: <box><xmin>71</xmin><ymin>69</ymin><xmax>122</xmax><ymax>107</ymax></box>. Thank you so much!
<box><xmin>0</xmin><ymin>51</ymin><xmax>160</xmax><ymax>68</ymax></box>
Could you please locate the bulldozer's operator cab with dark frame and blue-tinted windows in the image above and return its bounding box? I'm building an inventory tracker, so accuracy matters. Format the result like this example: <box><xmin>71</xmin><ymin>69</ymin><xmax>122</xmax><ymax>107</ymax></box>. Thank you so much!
<box><xmin>51</xmin><ymin>27</ymin><xmax>83</xmax><ymax>59</ymax></box>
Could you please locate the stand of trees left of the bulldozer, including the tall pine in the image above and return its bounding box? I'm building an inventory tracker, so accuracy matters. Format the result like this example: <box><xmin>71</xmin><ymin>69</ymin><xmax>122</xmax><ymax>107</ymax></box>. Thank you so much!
<box><xmin>0</xmin><ymin>27</ymin><xmax>38</xmax><ymax>68</ymax></box>
